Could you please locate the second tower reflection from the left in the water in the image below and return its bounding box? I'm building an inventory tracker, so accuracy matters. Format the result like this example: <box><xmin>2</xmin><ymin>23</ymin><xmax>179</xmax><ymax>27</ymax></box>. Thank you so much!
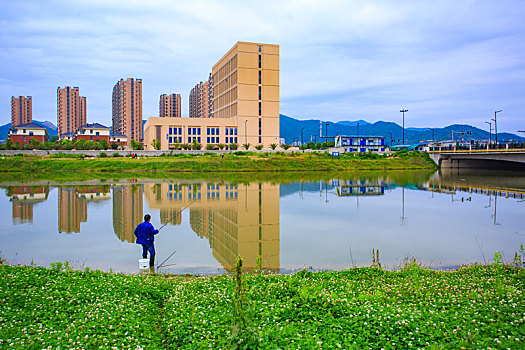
<box><xmin>58</xmin><ymin>187</ymin><xmax>87</xmax><ymax>233</ymax></box>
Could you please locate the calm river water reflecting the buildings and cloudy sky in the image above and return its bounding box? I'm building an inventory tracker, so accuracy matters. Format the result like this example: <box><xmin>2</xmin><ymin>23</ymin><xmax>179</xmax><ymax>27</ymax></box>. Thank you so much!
<box><xmin>0</xmin><ymin>171</ymin><xmax>525</xmax><ymax>274</ymax></box>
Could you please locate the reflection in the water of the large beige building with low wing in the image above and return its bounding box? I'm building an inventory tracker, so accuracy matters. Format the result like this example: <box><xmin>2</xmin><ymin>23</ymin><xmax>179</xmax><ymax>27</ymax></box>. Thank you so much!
<box><xmin>145</xmin><ymin>183</ymin><xmax>280</xmax><ymax>271</ymax></box>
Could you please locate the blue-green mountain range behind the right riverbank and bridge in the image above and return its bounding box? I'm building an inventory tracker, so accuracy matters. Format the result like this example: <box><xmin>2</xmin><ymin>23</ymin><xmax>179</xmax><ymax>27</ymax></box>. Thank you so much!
<box><xmin>280</xmin><ymin>114</ymin><xmax>525</xmax><ymax>144</ymax></box>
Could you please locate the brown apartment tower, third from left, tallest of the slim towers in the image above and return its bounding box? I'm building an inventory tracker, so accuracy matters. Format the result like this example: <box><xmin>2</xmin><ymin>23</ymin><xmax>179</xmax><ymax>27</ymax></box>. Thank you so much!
<box><xmin>113</xmin><ymin>78</ymin><xmax>142</xmax><ymax>143</ymax></box>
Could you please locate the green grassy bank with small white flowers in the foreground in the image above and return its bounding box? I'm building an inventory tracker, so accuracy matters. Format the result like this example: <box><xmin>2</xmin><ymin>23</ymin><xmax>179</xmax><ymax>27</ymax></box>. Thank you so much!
<box><xmin>0</xmin><ymin>264</ymin><xmax>525</xmax><ymax>349</ymax></box>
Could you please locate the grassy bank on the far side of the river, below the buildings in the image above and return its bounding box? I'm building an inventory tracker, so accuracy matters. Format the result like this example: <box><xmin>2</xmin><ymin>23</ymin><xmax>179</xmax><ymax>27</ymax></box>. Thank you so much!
<box><xmin>0</xmin><ymin>152</ymin><xmax>435</xmax><ymax>172</ymax></box>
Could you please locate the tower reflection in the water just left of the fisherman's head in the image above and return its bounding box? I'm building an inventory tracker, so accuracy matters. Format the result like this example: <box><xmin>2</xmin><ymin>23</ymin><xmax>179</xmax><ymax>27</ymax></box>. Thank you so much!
<box><xmin>113</xmin><ymin>185</ymin><xmax>144</xmax><ymax>243</ymax></box>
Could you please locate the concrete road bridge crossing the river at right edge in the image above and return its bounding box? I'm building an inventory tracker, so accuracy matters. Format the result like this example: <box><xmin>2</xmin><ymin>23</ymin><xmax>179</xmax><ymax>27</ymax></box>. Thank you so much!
<box><xmin>428</xmin><ymin>149</ymin><xmax>525</xmax><ymax>169</ymax></box>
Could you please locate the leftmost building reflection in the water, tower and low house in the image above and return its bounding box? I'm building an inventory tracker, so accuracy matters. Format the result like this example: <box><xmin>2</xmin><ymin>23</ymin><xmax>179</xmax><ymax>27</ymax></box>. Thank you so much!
<box><xmin>7</xmin><ymin>186</ymin><xmax>49</xmax><ymax>225</ymax></box>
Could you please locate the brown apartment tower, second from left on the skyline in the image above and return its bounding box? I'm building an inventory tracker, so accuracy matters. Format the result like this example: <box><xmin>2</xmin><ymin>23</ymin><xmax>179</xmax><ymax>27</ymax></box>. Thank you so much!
<box><xmin>57</xmin><ymin>86</ymin><xmax>87</xmax><ymax>138</ymax></box>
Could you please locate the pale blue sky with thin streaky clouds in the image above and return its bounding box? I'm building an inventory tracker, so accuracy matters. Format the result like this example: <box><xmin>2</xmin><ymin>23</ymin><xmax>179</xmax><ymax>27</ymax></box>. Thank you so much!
<box><xmin>0</xmin><ymin>0</ymin><xmax>525</xmax><ymax>133</ymax></box>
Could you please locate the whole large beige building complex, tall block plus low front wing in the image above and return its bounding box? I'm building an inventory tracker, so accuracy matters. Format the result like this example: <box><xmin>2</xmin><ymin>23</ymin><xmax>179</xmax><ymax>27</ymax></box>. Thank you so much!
<box><xmin>144</xmin><ymin>42</ymin><xmax>279</xmax><ymax>150</ymax></box>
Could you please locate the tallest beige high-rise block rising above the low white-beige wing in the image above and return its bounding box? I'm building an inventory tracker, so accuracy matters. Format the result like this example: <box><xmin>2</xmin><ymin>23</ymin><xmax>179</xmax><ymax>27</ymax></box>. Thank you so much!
<box><xmin>212</xmin><ymin>42</ymin><xmax>279</xmax><ymax>145</ymax></box>
